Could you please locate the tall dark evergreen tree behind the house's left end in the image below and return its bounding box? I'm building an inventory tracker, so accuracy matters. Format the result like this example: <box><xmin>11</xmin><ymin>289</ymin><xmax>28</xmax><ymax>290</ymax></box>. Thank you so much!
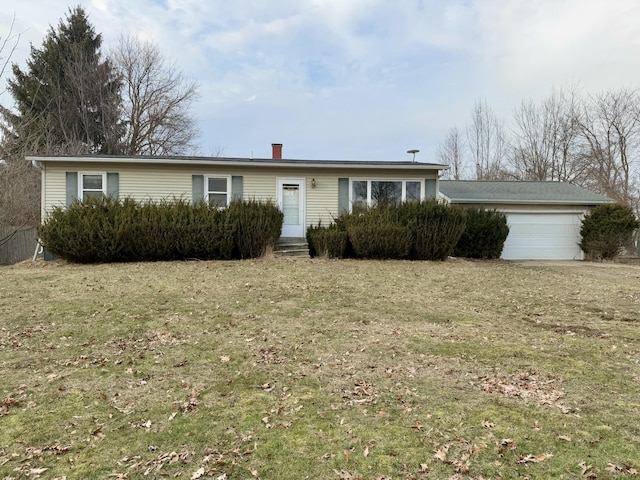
<box><xmin>0</xmin><ymin>7</ymin><xmax>124</xmax><ymax>156</ymax></box>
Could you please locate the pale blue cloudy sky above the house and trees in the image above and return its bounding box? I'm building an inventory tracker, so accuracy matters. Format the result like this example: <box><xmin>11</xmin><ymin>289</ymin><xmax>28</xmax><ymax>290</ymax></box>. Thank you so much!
<box><xmin>0</xmin><ymin>0</ymin><xmax>640</xmax><ymax>162</ymax></box>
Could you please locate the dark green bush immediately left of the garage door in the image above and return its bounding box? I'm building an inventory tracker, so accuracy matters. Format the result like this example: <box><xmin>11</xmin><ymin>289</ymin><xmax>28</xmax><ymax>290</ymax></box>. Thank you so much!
<box><xmin>453</xmin><ymin>208</ymin><xmax>509</xmax><ymax>259</ymax></box>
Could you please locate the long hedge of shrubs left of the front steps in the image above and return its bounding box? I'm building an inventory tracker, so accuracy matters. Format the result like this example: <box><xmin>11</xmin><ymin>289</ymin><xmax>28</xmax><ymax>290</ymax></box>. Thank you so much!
<box><xmin>38</xmin><ymin>198</ymin><xmax>283</xmax><ymax>263</ymax></box>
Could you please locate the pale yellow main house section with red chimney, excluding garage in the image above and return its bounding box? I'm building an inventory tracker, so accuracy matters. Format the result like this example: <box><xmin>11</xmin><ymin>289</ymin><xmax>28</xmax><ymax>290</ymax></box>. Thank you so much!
<box><xmin>27</xmin><ymin>144</ymin><xmax>448</xmax><ymax>237</ymax></box>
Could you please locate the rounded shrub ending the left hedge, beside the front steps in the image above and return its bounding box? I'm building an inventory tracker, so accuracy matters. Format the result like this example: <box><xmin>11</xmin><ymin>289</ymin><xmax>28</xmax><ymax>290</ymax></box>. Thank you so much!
<box><xmin>227</xmin><ymin>200</ymin><xmax>284</xmax><ymax>258</ymax></box>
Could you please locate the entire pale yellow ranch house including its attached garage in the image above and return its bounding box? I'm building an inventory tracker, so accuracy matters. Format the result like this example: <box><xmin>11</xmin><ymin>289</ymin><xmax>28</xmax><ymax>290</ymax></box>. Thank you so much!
<box><xmin>27</xmin><ymin>143</ymin><xmax>612</xmax><ymax>260</ymax></box>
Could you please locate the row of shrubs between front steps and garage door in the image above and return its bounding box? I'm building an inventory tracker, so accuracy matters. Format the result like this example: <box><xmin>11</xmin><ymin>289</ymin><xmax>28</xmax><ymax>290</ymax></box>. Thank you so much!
<box><xmin>307</xmin><ymin>200</ymin><xmax>509</xmax><ymax>260</ymax></box>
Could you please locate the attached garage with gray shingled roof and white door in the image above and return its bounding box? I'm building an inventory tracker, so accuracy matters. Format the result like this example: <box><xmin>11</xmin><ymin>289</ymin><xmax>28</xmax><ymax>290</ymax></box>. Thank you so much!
<box><xmin>438</xmin><ymin>180</ymin><xmax>613</xmax><ymax>260</ymax></box>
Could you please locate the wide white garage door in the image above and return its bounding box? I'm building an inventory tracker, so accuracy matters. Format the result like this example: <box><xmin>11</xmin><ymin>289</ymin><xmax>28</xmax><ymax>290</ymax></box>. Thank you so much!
<box><xmin>502</xmin><ymin>212</ymin><xmax>583</xmax><ymax>260</ymax></box>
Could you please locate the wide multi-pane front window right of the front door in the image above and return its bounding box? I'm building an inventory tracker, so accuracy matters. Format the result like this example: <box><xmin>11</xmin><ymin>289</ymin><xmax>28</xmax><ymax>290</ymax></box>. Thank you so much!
<box><xmin>350</xmin><ymin>180</ymin><xmax>423</xmax><ymax>207</ymax></box>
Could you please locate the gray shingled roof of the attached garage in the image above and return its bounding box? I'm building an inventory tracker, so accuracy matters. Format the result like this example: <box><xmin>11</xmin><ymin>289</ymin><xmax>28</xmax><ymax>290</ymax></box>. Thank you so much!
<box><xmin>440</xmin><ymin>180</ymin><xmax>613</xmax><ymax>205</ymax></box>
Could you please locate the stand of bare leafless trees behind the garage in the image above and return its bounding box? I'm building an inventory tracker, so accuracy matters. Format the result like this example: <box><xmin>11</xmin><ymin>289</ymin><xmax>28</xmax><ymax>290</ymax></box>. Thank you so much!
<box><xmin>437</xmin><ymin>86</ymin><xmax>640</xmax><ymax>215</ymax></box>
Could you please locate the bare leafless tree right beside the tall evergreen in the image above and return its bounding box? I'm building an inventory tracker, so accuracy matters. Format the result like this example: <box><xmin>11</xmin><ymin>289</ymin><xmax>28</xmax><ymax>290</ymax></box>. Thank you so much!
<box><xmin>113</xmin><ymin>36</ymin><xmax>198</xmax><ymax>155</ymax></box>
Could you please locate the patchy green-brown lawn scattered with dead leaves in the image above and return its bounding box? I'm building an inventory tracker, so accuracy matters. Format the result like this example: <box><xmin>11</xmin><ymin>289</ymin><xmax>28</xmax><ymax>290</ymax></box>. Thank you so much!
<box><xmin>0</xmin><ymin>258</ymin><xmax>640</xmax><ymax>480</ymax></box>
